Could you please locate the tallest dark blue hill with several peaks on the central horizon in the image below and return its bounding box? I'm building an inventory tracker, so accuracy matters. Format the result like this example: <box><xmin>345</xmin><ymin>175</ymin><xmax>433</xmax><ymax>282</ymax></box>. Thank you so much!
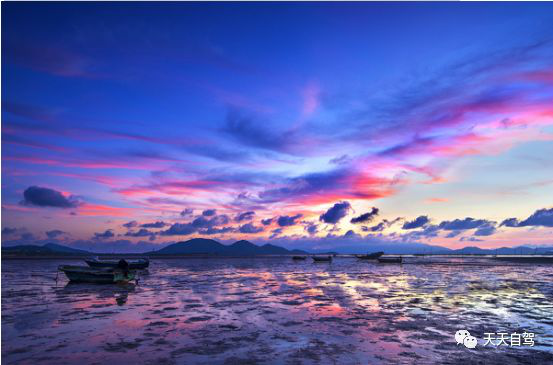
<box><xmin>149</xmin><ymin>238</ymin><xmax>307</xmax><ymax>256</ymax></box>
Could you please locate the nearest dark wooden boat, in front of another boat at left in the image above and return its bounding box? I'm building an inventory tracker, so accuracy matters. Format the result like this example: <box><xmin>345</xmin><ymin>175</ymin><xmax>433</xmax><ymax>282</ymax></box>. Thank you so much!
<box><xmin>58</xmin><ymin>265</ymin><xmax>136</xmax><ymax>284</ymax></box>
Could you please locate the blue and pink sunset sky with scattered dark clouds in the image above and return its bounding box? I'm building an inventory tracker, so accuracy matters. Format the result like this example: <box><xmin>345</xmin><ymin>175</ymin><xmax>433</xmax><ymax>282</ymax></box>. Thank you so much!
<box><xmin>2</xmin><ymin>2</ymin><xmax>553</xmax><ymax>251</ymax></box>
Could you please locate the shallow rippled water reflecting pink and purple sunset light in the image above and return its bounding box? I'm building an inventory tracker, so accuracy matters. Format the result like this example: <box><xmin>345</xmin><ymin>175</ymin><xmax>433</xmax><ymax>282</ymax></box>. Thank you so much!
<box><xmin>2</xmin><ymin>257</ymin><xmax>553</xmax><ymax>365</ymax></box>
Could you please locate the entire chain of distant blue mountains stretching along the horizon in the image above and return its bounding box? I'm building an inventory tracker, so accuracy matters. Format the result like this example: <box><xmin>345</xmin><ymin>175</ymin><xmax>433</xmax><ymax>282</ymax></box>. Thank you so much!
<box><xmin>2</xmin><ymin>238</ymin><xmax>553</xmax><ymax>256</ymax></box>
